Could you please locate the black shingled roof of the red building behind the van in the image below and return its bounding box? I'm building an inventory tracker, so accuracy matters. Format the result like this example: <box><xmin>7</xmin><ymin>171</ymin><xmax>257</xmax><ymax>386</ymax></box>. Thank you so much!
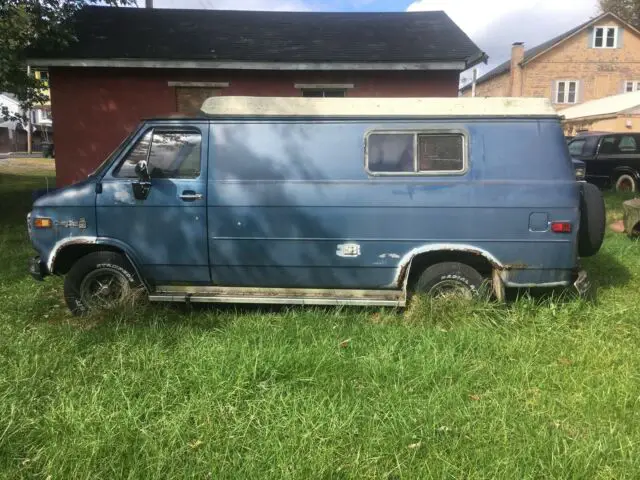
<box><xmin>29</xmin><ymin>6</ymin><xmax>485</xmax><ymax>70</ymax></box>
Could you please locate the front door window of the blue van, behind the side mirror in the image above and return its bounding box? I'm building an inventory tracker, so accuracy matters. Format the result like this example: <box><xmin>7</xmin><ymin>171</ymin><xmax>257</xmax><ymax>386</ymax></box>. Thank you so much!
<box><xmin>114</xmin><ymin>128</ymin><xmax>202</xmax><ymax>178</ymax></box>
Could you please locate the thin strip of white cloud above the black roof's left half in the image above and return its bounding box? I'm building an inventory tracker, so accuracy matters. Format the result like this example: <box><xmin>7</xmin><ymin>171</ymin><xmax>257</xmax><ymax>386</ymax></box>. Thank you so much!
<box><xmin>148</xmin><ymin>0</ymin><xmax>311</xmax><ymax>12</ymax></box>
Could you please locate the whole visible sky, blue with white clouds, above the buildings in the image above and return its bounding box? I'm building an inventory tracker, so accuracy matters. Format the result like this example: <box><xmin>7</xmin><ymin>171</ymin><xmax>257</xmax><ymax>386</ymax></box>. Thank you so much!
<box><xmin>149</xmin><ymin>0</ymin><xmax>598</xmax><ymax>77</ymax></box>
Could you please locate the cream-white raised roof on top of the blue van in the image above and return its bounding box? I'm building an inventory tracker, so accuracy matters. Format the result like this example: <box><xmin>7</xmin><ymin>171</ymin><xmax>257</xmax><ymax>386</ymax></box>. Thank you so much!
<box><xmin>201</xmin><ymin>96</ymin><xmax>558</xmax><ymax>117</ymax></box>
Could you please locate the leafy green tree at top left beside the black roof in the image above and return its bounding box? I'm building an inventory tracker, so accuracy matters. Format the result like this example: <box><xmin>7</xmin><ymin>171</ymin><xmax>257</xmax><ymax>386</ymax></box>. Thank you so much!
<box><xmin>0</xmin><ymin>0</ymin><xmax>135</xmax><ymax>119</ymax></box>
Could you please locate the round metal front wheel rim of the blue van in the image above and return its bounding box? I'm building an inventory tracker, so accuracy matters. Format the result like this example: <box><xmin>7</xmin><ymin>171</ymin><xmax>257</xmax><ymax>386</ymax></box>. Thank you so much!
<box><xmin>80</xmin><ymin>268</ymin><xmax>129</xmax><ymax>309</ymax></box>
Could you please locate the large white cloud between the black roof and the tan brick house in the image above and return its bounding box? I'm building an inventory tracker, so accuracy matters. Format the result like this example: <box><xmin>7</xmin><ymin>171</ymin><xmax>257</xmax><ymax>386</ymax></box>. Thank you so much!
<box><xmin>407</xmin><ymin>0</ymin><xmax>598</xmax><ymax>73</ymax></box>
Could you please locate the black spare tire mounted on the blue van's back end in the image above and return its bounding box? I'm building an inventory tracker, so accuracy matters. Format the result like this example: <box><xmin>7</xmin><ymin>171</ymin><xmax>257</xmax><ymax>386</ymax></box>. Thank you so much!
<box><xmin>578</xmin><ymin>183</ymin><xmax>606</xmax><ymax>257</ymax></box>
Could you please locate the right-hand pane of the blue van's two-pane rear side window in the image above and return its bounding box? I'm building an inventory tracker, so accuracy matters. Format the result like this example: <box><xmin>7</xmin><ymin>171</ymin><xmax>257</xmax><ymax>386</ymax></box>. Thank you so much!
<box><xmin>418</xmin><ymin>135</ymin><xmax>464</xmax><ymax>172</ymax></box>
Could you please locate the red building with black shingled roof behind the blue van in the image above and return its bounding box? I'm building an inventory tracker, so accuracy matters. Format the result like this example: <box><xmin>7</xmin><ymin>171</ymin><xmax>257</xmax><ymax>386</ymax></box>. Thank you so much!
<box><xmin>29</xmin><ymin>7</ymin><xmax>486</xmax><ymax>186</ymax></box>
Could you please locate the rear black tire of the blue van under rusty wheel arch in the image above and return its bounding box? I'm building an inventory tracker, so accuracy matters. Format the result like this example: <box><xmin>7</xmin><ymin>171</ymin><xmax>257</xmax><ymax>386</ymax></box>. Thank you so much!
<box><xmin>413</xmin><ymin>262</ymin><xmax>487</xmax><ymax>300</ymax></box>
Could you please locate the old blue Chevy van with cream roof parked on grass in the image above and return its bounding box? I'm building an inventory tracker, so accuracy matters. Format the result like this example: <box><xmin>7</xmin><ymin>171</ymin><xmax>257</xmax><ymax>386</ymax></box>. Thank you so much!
<box><xmin>27</xmin><ymin>97</ymin><xmax>604</xmax><ymax>314</ymax></box>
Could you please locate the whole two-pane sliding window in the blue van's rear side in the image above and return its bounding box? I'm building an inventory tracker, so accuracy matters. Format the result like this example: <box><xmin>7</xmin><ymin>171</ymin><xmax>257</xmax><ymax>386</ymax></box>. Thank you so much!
<box><xmin>366</xmin><ymin>132</ymin><xmax>466</xmax><ymax>174</ymax></box>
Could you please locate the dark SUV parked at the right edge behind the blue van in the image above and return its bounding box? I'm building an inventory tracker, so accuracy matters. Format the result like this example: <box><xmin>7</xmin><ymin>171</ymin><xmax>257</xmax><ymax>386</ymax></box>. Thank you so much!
<box><xmin>568</xmin><ymin>132</ymin><xmax>640</xmax><ymax>192</ymax></box>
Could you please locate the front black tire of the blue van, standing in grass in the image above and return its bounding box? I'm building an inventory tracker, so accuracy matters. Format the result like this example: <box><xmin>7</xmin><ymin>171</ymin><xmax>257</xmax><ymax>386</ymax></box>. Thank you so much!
<box><xmin>64</xmin><ymin>251</ymin><xmax>140</xmax><ymax>315</ymax></box>
